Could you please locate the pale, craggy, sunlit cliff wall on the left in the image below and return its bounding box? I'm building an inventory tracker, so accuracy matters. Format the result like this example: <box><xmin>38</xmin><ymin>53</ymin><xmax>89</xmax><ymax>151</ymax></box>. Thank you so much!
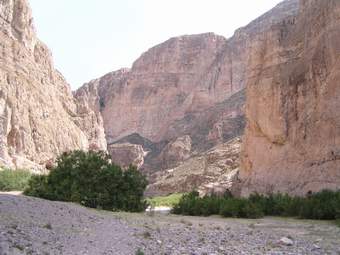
<box><xmin>0</xmin><ymin>0</ymin><xmax>106</xmax><ymax>168</ymax></box>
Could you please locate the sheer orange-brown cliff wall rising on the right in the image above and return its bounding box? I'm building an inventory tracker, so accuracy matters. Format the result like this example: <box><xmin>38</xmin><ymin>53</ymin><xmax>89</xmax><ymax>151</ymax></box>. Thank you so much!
<box><xmin>240</xmin><ymin>0</ymin><xmax>340</xmax><ymax>195</ymax></box>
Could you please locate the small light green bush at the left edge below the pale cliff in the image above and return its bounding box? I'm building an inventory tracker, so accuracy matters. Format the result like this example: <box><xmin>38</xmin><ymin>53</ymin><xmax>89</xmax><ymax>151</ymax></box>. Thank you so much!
<box><xmin>0</xmin><ymin>169</ymin><xmax>32</xmax><ymax>191</ymax></box>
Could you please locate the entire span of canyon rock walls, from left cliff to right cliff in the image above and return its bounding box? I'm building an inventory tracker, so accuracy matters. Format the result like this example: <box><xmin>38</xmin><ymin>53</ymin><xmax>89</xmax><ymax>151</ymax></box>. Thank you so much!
<box><xmin>0</xmin><ymin>0</ymin><xmax>340</xmax><ymax>196</ymax></box>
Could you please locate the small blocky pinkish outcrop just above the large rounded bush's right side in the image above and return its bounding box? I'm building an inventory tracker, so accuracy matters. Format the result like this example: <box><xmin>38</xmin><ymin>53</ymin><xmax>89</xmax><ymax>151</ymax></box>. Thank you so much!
<box><xmin>108</xmin><ymin>143</ymin><xmax>146</xmax><ymax>169</ymax></box>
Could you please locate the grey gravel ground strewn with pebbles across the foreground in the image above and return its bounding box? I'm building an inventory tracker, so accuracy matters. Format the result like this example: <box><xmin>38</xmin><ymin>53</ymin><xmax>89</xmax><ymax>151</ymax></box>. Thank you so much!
<box><xmin>0</xmin><ymin>194</ymin><xmax>340</xmax><ymax>255</ymax></box>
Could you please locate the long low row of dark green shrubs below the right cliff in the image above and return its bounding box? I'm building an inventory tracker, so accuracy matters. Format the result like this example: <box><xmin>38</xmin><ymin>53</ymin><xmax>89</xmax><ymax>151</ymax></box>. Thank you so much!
<box><xmin>172</xmin><ymin>190</ymin><xmax>340</xmax><ymax>222</ymax></box>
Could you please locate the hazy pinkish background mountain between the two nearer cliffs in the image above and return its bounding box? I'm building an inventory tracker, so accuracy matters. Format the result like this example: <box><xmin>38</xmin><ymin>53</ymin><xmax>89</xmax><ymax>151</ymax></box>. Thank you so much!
<box><xmin>76</xmin><ymin>0</ymin><xmax>298</xmax><ymax>179</ymax></box>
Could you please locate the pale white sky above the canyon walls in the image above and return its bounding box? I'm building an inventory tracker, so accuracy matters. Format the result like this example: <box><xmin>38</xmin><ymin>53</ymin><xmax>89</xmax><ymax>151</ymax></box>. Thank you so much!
<box><xmin>30</xmin><ymin>0</ymin><xmax>281</xmax><ymax>89</ymax></box>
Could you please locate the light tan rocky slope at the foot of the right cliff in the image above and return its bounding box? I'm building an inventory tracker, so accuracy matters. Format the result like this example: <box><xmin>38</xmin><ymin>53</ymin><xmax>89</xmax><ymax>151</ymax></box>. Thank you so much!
<box><xmin>146</xmin><ymin>138</ymin><xmax>241</xmax><ymax>196</ymax></box>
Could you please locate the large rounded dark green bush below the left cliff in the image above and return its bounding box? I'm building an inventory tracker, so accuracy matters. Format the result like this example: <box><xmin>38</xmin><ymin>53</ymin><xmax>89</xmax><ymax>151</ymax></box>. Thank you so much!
<box><xmin>24</xmin><ymin>151</ymin><xmax>147</xmax><ymax>212</ymax></box>
